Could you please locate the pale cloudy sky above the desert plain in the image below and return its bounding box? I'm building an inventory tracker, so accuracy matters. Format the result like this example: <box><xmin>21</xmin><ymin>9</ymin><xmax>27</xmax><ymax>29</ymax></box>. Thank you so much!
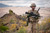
<box><xmin>0</xmin><ymin>0</ymin><xmax>50</xmax><ymax>7</ymax></box>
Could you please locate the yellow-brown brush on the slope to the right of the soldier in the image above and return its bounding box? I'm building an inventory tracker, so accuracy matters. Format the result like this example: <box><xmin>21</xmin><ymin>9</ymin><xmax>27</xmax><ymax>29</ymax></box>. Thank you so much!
<box><xmin>37</xmin><ymin>17</ymin><xmax>50</xmax><ymax>33</ymax></box>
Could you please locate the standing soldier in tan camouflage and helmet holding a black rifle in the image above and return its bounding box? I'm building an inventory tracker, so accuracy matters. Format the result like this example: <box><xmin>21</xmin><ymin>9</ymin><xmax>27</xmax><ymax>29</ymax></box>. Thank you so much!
<box><xmin>27</xmin><ymin>3</ymin><xmax>40</xmax><ymax>32</ymax></box>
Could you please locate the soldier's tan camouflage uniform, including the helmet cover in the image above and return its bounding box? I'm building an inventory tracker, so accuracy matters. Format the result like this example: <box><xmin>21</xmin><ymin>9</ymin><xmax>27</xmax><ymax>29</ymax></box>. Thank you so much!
<box><xmin>27</xmin><ymin>4</ymin><xmax>39</xmax><ymax>33</ymax></box>
